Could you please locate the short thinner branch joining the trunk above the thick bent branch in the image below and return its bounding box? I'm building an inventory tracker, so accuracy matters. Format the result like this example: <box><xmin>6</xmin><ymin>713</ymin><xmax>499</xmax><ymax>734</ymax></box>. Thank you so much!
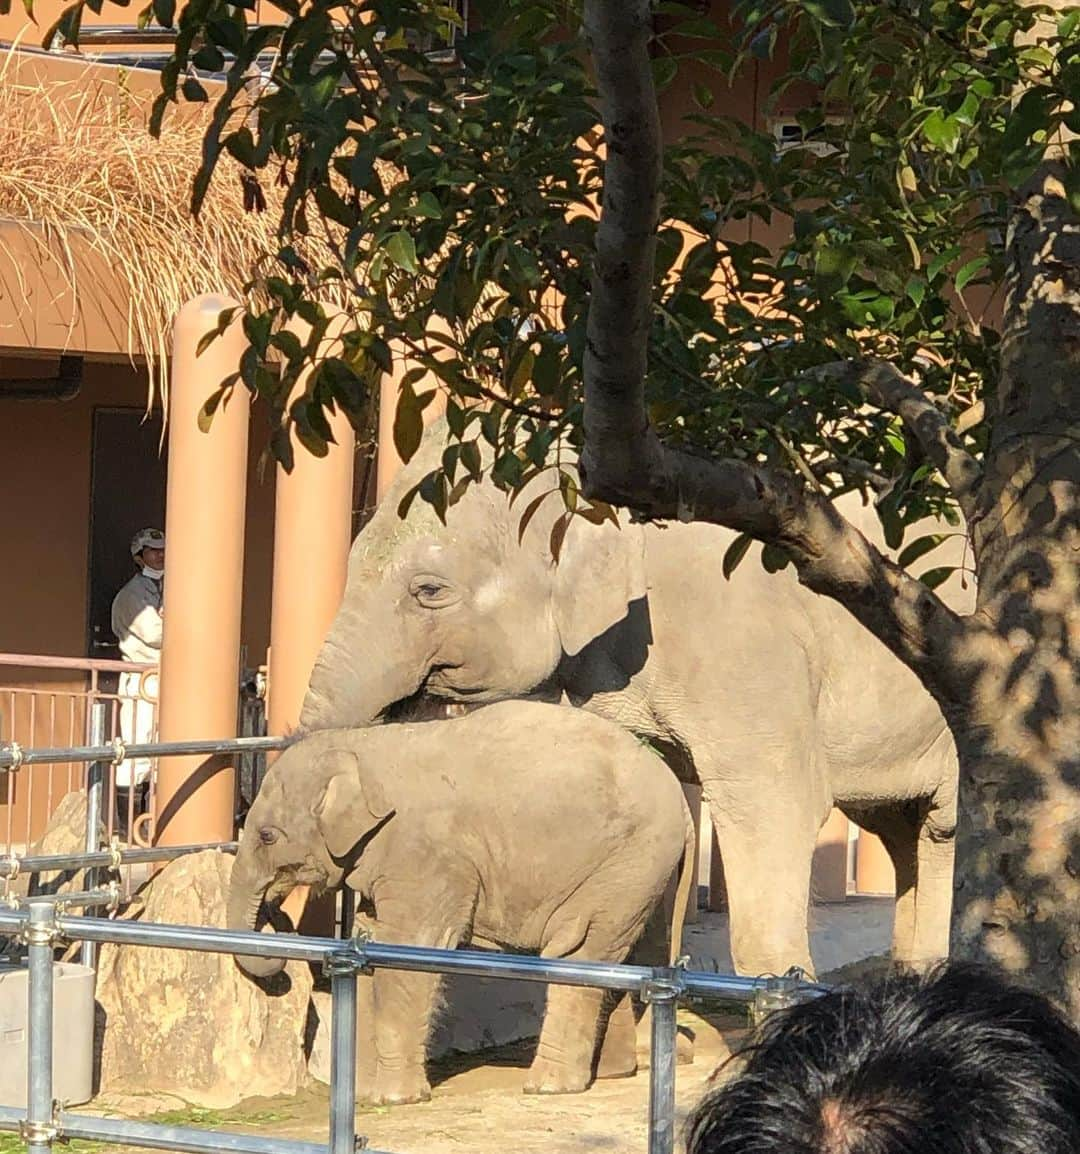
<box><xmin>811</xmin><ymin>361</ymin><xmax>982</xmax><ymax>522</ymax></box>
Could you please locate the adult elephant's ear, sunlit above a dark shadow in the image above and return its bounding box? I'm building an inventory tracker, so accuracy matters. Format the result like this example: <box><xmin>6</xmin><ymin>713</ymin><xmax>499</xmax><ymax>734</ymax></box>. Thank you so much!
<box><xmin>553</xmin><ymin>512</ymin><xmax>648</xmax><ymax>657</ymax></box>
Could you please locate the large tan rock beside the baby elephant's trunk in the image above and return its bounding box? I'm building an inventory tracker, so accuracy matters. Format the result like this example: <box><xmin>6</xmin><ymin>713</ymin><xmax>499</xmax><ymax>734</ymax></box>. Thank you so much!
<box><xmin>97</xmin><ymin>850</ymin><xmax>312</xmax><ymax>1108</ymax></box>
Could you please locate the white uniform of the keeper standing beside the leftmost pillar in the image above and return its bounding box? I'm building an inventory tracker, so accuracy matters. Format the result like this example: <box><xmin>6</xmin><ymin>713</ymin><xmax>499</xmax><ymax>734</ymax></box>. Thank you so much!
<box><xmin>112</xmin><ymin>572</ymin><xmax>162</xmax><ymax>788</ymax></box>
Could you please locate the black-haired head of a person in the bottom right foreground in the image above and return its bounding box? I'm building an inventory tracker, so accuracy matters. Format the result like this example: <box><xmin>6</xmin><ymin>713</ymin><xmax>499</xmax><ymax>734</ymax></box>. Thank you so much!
<box><xmin>687</xmin><ymin>965</ymin><xmax>1080</xmax><ymax>1154</ymax></box>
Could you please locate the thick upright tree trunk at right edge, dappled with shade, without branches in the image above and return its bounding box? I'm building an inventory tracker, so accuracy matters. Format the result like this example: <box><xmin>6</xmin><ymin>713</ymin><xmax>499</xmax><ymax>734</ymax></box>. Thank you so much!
<box><xmin>951</xmin><ymin>164</ymin><xmax>1080</xmax><ymax>1018</ymax></box>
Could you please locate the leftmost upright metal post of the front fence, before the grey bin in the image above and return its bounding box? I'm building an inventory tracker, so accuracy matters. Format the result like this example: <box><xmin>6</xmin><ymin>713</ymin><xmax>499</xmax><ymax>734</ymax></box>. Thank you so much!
<box><xmin>23</xmin><ymin>902</ymin><xmax>57</xmax><ymax>1154</ymax></box>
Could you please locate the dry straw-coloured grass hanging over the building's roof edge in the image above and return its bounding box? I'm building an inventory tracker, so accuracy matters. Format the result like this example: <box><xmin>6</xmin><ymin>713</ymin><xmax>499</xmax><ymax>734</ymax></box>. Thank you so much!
<box><xmin>0</xmin><ymin>50</ymin><xmax>341</xmax><ymax>407</ymax></box>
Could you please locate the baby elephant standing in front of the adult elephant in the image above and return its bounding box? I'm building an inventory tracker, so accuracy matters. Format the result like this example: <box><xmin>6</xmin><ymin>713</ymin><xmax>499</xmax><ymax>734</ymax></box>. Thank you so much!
<box><xmin>228</xmin><ymin>702</ymin><xmax>693</xmax><ymax>1103</ymax></box>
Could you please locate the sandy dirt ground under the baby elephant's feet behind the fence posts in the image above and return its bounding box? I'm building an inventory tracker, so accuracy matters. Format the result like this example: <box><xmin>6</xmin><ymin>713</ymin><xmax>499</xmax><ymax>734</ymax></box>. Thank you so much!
<box><xmin>95</xmin><ymin>1010</ymin><xmax>745</xmax><ymax>1154</ymax></box>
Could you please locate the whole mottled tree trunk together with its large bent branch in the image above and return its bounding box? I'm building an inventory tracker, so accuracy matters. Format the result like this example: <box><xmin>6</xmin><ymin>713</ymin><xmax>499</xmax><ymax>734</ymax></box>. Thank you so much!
<box><xmin>582</xmin><ymin>0</ymin><xmax>1080</xmax><ymax>1019</ymax></box>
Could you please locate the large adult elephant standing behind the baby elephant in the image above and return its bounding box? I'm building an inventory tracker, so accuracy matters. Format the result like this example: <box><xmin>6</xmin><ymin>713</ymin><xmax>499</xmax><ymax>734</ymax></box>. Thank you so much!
<box><xmin>300</xmin><ymin>421</ymin><xmax>957</xmax><ymax>974</ymax></box>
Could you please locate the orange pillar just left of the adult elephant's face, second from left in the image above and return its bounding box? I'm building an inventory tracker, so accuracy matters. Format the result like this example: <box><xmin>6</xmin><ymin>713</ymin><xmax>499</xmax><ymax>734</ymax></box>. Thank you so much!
<box><xmin>267</xmin><ymin>322</ymin><xmax>355</xmax><ymax>935</ymax></box>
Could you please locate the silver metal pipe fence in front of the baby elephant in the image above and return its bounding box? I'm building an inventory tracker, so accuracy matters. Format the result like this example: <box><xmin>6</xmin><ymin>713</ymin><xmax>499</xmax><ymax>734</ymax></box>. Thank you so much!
<box><xmin>0</xmin><ymin>737</ymin><xmax>822</xmax><ymax>1154</ymax></box>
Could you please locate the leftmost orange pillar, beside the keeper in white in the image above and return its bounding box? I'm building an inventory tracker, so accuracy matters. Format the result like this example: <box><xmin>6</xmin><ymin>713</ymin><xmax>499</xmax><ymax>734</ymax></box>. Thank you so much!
<box><xmin>156</xmin><ymin>295</ymin><xmax>249</xmax><ymax>846</ymax></box>
